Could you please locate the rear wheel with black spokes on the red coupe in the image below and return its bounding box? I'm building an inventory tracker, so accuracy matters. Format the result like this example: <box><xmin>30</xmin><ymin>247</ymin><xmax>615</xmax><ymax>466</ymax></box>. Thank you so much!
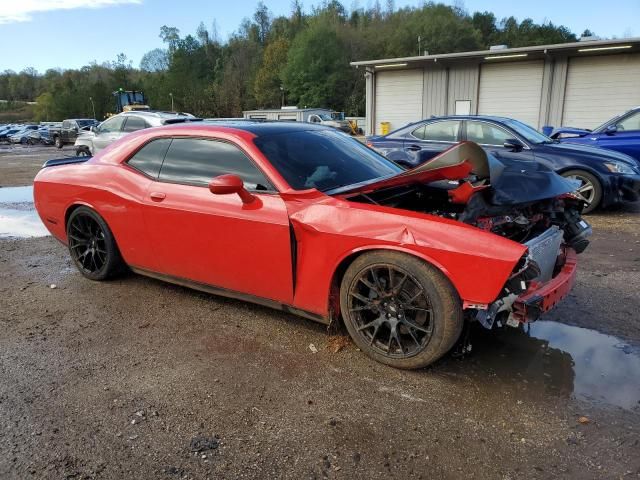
<box><xmin>67</xmin><ymin>206</ymin><xmax>125</xmax><ymax>280</ymax></box>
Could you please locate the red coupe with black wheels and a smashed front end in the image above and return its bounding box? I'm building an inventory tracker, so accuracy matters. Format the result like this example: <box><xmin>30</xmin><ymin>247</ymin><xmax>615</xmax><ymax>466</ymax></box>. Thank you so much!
<box><xmin>34</xmin><ymin>122</ymin><xmax>591</xmax><ymax>368</ymax></box>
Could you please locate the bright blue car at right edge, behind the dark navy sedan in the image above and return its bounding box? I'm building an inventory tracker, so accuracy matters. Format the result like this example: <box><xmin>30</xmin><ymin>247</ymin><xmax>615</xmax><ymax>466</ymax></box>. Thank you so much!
<box><xmin>551</xmin><ymin>107</ymin><xmax>640</xmax><ymax>161</ymax></box>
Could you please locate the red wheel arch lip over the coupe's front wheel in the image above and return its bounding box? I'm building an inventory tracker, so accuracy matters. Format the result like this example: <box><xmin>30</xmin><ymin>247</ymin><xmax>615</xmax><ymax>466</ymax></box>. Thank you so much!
<box><xmin>328</xmin><ymin>245</ymin><xmax>460</xmax><ymax>322</ymax></box>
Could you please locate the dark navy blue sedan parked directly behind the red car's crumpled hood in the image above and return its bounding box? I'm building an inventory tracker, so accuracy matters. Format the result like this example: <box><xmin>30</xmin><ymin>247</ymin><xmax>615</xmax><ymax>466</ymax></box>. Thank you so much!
<box><xmin>367</xmin><ymin>115</ymin><xmax>640</xmax><ymax>213</ymax></box>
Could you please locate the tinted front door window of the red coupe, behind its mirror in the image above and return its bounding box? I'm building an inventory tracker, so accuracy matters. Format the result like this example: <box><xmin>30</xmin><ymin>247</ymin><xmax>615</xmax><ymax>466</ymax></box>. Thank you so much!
<box><xmin>160</xmin><ymin>138</ymin><xmax>274</xmax><ymax>190</ymax></box>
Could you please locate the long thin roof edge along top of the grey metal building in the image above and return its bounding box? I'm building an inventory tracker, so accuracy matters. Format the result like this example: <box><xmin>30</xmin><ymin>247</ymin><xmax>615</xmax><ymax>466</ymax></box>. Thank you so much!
<box><xmin>351</xmin><ymin>37</ymin><xmax>640</xmax><ymax>68</ymax></box>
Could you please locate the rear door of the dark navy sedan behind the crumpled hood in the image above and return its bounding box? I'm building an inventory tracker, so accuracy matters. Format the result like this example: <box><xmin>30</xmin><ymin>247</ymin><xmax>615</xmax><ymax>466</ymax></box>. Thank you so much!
<box><xmin>403</xmin><ymin>120</ymin><xmax>462</xmax><ymax>166</ymax></box>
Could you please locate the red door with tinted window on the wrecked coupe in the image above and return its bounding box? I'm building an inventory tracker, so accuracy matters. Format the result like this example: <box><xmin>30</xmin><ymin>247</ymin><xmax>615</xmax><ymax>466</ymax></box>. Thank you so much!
<box><xmin>145</xmin><ymin>138</ymin><xmax>293</xmax><ymax>303</ymax></box>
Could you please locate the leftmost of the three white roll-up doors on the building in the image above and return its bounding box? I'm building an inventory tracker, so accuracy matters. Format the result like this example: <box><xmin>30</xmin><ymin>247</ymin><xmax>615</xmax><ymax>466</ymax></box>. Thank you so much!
<box><xmin>375</xmin><ymin>70</ymin><xmax>424</xmax><ymax>134</ymax></box>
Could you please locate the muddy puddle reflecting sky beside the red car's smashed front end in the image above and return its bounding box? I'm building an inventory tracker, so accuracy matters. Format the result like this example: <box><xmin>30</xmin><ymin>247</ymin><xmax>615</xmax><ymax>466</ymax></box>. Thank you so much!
<box><xmin>444</xmin><ymin>321</ymin><xmax>640</xmax><ymax>409</ymax></box>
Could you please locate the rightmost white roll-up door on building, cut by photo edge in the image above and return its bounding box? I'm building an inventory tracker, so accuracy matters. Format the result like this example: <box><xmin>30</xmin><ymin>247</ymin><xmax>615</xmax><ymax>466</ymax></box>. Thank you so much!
<box><xmin>562</xmin><ymin>53</ymin><xmax>640</xmax><ymax>128</ymax></box>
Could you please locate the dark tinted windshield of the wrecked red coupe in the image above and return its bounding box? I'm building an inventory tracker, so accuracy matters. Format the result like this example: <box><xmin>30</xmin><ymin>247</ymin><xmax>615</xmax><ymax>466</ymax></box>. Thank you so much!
<box><xmin>253</xmin><ymin>130</ymin><xmax>403</xmax><ymax>192</ymax></box>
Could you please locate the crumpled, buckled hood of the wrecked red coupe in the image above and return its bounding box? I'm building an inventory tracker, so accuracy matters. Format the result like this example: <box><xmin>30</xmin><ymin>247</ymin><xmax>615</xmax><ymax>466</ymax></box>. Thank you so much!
<box><xmin>328</xmin><ymin>142</ymin><xmax>578</xmax><ymax>205</ymax></box>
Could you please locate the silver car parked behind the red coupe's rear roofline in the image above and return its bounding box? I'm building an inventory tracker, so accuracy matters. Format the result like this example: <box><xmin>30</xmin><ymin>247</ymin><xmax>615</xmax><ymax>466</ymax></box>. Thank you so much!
<box><xmin>75</xmin><ymin>110</ymin><xmax>201</xmax><ymax>156</ymax></box>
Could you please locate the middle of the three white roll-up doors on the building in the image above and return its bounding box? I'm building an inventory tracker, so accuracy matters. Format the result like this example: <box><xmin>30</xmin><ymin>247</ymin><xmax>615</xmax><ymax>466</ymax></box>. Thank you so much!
<box><xmin>478</xmin><ymin>60</ymin><xmax>544</xmax><ymax>128</ymax></box>
